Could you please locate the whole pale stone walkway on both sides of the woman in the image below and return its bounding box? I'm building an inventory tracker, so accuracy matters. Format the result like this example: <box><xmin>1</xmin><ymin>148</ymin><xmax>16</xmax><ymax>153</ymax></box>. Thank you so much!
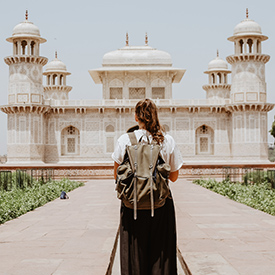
<box><xmin>0</xmin><ymin>179</ymin><xmax>275</xmax><ymax>275</ymax></box>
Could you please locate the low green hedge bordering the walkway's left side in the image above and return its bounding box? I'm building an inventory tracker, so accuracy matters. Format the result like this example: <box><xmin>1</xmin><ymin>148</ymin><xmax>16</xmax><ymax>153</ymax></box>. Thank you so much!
<box><xmin>0</xmin><ymin>179</ymin><xmax>84</xmax><ymax>224</ymax></box>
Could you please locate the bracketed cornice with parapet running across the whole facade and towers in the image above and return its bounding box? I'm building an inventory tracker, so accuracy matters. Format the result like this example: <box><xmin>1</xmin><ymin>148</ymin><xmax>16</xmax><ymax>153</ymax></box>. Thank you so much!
<box><xmin>0</xmin><ymin>99</ymin><xmax>275</xmax><ymax>114</ymax></box>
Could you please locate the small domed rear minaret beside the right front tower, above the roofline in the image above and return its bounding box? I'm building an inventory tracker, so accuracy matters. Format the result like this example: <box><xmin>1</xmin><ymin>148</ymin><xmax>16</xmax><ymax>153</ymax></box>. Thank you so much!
<box><xmin>202</xmin><ymin>51</ymin><xmax>231</xmax><ymax>99</ymax></box>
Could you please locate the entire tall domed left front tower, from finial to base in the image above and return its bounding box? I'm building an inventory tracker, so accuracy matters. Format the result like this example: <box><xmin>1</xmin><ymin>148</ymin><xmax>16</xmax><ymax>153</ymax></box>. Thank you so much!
<box><xmin>4</xmin><ymin>12</ymin><xmax>49</xmax><ymax>163</ymax></box>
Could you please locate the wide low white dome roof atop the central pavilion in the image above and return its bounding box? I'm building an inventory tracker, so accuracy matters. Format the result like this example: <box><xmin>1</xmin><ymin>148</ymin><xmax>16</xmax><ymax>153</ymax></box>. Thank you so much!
<box><xmin>102</xmin><ymin>46</ymin><xmax>172</xmax><ymax>67</ymax></box>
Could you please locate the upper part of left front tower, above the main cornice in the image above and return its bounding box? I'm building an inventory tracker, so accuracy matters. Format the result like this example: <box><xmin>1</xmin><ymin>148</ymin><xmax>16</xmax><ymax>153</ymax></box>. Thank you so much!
<box><xmin>4</xmin><ymin>11</ymin><xmax>48</xmax><ymax>104</ymax></box>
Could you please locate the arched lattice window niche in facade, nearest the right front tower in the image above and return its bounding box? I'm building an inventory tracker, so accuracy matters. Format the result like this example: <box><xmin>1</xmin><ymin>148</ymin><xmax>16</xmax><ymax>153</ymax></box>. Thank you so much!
<box><xmin>196</xmin><ymin>125</ymin><xmax>214</xmax><ymax>155</ymax></box>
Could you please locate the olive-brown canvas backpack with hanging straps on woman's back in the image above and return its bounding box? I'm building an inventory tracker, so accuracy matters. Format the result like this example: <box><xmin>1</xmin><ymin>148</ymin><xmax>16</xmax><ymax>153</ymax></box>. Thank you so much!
<box><xmin>116</xmin><ymin>132</ymin><xmax>171</xmax><ymax>220</ymax></box>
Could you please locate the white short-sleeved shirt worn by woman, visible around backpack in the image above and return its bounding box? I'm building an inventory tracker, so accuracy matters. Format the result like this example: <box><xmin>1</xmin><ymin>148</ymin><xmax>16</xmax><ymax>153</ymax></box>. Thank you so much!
<box><xmin>112</xmin><ymin>129</ymin><xmax>183</xmax><ymax>172</ymax></box>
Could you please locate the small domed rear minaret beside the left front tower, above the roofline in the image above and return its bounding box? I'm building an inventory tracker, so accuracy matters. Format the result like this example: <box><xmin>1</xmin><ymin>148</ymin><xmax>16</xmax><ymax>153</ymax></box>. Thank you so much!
<box><xmin>43</xmin><ymin>52</ymin><xmax>72</xmax><ymax>100</ymax></box>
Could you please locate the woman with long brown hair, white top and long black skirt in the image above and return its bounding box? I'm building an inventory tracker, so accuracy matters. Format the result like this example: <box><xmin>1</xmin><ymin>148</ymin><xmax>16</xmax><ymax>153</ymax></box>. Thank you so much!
<box><xmin>112</xmin><ymin>99</ymin><xmax>183</xmax><ymax>275</ymax></box>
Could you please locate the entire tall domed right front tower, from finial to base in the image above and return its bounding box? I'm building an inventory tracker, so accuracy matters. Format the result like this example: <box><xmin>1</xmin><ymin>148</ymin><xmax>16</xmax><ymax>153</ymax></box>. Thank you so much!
<box><xmin>226</xmin><ymin>10</ymin><xmax>273</xmax><ymax>161</ymax></box>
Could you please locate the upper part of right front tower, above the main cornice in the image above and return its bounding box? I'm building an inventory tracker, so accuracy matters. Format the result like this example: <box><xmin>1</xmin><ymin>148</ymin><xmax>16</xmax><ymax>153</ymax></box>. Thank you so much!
<box><xmin>226</xmin><ymin>10</ymin><xmax>270</xmax><ymax>103</ymax></box>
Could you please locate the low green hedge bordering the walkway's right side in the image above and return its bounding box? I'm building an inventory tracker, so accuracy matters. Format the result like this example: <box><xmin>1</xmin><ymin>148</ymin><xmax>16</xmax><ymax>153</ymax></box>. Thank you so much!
<box><xmin>194</xmin><ymin>179</ymin><xmax>275</xmax><ymax>215</ymax></box>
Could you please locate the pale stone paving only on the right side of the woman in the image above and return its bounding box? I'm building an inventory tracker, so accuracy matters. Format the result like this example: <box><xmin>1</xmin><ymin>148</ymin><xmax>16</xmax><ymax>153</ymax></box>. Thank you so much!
<box><xmin>174</xmin><ymin>179</ymin><xmax>275</xmax><ymax>275</ymax></box>
